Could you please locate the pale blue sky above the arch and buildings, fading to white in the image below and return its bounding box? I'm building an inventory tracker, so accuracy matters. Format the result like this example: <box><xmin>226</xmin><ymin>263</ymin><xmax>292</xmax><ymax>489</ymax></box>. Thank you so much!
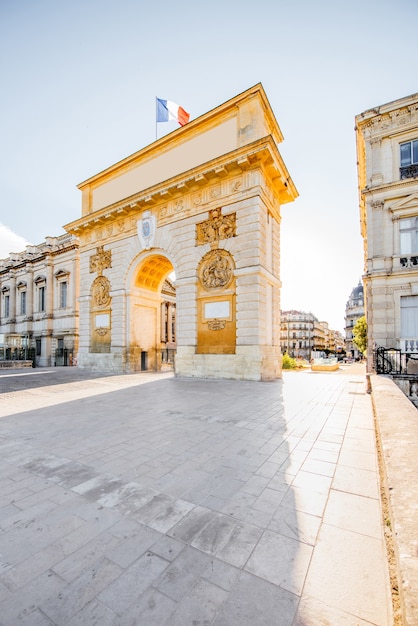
<box><xmin>0</xmin><ymin>0</ymin><xmax>418</xmax><ymax>330</ymax></box>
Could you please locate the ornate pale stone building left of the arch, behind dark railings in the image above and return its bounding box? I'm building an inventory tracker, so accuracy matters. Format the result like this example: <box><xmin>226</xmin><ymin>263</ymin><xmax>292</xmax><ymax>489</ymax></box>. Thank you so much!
<box><xmin>0</xmin><ymin>234</ymin><xmax>79</xmax><ymax>366</ymax></box>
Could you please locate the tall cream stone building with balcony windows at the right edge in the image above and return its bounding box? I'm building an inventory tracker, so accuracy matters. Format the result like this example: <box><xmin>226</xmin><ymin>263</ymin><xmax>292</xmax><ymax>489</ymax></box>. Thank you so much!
<box><xmin>355</xmin><ymin>94</ymin><xmax>418</xmax><ymax>371</ymax></box>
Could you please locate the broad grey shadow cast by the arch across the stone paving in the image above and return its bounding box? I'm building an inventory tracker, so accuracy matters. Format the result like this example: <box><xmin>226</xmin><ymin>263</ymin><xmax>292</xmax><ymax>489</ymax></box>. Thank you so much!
<box><xmin>0</xmin><ymin>368</ymin><xmax>306</xmax><ymax>626</ymax></box>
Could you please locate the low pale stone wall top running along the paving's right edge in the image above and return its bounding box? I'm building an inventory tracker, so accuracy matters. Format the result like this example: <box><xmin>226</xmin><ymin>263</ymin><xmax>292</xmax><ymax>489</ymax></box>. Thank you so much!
<box><xmin>369</xmin><ymin>374</ymin><xmax>418</xmax><ymax>626</ymax></box>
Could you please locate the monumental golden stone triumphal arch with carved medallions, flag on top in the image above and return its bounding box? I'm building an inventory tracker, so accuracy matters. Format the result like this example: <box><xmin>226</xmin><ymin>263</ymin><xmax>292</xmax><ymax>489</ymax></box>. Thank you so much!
<box><xmin>65</xmin><ymin>84</ymin><xmax>297</xmax><ymax>380</ymax></box>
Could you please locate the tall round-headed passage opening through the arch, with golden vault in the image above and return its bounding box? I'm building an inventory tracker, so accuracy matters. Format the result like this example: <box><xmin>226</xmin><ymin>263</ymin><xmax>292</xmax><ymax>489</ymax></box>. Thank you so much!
<box><xmin>130</xmin><ymin>251</ymin><xmax>176</xmax><ymax>371</ymax></box>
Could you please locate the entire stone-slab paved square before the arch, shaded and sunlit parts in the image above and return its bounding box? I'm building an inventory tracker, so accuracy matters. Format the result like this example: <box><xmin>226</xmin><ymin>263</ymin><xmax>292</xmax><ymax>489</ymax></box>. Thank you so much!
<box><xmin>0</xmin><ymin>365</ymin><xmax>392</xmax><ymax>626</ymax></box>
